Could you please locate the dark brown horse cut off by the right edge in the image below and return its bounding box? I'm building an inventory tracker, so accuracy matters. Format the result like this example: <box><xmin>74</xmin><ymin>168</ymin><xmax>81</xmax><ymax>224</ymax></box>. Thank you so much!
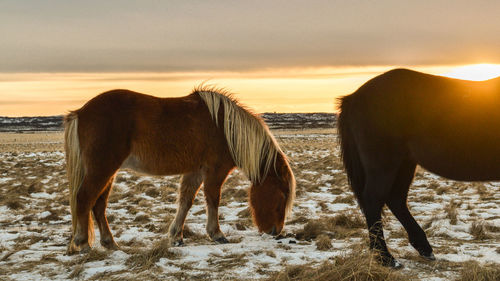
<box><xmin>338</xmin><ymin>69</ymin><xmax>500</xmax><ymax>267</ymax></box>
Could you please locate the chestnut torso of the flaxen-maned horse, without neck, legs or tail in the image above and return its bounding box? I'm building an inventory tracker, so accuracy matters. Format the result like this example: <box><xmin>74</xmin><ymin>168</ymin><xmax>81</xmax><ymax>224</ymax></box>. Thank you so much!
<box><xmin>73</xmin><ymin>90</ymin><xmax>229</xmax><ymax>174</ymax></box>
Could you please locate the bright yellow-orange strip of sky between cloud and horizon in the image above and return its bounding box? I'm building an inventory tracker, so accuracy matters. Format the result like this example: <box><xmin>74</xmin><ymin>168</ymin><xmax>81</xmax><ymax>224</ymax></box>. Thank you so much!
<box><xmin>0</xmin><ymin>65</ymin><xmax>500</xmax><ymax>116</ymax></box>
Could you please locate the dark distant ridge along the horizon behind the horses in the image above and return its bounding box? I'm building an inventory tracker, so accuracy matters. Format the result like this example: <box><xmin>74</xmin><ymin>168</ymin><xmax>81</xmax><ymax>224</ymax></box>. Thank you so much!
<box><xmin>0</xmin><ymin>113</ymin><xmax>337</xmax><ymax>132</ymax></box>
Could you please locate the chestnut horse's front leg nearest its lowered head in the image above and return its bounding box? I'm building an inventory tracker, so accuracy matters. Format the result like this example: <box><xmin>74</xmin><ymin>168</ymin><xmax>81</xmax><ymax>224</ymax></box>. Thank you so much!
<box><xmin>203</xmin><ymin>166</ymin><xmax>230</xmax><ymax>244</ymax></box>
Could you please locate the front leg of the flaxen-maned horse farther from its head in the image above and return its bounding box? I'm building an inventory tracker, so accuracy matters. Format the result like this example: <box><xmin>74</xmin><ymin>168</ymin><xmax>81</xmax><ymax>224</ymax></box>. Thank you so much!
<box><xmin>168</xmin><ymin>172</ymin><xmax>202</xmax><ymax>246</ymax></box>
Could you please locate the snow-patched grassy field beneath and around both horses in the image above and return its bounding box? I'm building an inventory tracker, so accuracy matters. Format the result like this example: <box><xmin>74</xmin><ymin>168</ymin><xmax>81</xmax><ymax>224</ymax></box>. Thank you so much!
<box><xmin>0</xmin><ymin>129</ymin><xmax>500</xmax><ymax>280</ymax></box>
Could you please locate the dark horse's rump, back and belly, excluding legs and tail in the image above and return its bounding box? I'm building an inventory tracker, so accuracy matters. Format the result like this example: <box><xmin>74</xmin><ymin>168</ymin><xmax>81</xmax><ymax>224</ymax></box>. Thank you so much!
<box><xmin>341</xmin><ymin>69</ymin><xmax>500</xmax><ymax>180</ymax></box>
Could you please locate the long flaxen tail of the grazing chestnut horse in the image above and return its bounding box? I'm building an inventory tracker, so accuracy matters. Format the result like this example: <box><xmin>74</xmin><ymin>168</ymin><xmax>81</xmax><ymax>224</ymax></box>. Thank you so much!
<box><xmin>64</xmin><ymin>112</ymin><xmax>94</xmax><ymax>245</ymax></box>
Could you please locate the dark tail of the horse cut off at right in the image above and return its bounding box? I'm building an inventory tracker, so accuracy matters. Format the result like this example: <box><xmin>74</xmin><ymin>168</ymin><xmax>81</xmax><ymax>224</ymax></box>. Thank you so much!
<box><xmin>338</xmin><ymin>95</ymin><xmax>365</xmax><ymax>210</ymax></box>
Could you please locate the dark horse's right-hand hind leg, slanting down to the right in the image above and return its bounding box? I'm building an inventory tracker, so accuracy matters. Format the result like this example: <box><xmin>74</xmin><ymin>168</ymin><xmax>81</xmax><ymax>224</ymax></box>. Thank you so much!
<box><xmin>387</xmin><ymin>160</ymin><xmax>435</xmax><ymax>260</ymax></box>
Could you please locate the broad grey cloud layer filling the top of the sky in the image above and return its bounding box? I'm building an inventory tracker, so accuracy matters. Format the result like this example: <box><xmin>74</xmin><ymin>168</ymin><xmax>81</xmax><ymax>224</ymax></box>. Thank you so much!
<box><xmin>0</xmin><ymin>0</ymin><xmax>500</xmax><ymax>72</ymax></box>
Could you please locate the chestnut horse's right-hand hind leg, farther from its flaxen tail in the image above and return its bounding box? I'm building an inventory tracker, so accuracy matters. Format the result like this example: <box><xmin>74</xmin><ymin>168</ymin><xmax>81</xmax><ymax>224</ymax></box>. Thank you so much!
<box><xmin>92</xmin><ymin>176</ymin><xmax>118</xmax><ymax>250</ymax></box>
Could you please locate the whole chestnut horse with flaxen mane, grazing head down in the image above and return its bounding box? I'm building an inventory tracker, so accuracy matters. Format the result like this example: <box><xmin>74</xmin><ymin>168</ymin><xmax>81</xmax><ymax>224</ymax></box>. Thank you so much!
<box><xmin>65</xmin><ymin>87</ymin><xmax>295</xmax><ymax>254</ymax></box>
